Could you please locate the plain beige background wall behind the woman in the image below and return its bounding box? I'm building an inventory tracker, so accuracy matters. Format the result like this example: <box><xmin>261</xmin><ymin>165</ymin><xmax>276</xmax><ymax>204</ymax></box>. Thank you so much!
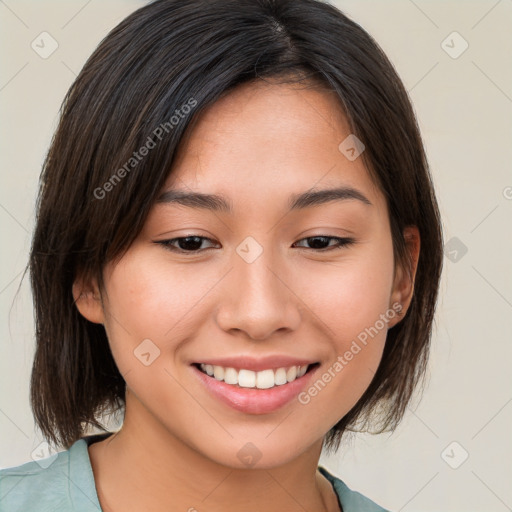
<box><xmin>0</xmin><ymin>0</ymin><xmax>512</xmax><ymax>512</ymax></box>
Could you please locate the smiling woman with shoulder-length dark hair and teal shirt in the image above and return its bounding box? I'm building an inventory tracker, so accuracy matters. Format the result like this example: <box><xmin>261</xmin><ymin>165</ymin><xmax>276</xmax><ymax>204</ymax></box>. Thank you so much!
<box><xmin>0</xmin><ymin>0</ymin><xmax>442</xmax><ymax>512</ymax></box>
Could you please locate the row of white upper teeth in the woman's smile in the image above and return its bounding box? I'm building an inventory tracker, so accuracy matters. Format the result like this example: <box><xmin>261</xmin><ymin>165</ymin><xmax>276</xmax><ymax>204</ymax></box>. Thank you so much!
<box><xmin>199</xmin><ymin>364</ymin><xmax>309</xmax><ymax>389</ymax></box>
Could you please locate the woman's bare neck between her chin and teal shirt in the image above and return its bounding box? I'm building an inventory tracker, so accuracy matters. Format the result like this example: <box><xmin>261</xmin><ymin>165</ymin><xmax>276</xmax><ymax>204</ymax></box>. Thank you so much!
<box><xmin>89</xmin><ymin>393</ymin><xmax>339</xmax><ymax>512</ymax></box>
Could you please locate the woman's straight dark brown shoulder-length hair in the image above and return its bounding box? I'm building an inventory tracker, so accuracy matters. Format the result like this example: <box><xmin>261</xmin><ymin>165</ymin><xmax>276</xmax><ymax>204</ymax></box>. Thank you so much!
<box><xmin>29</xmin><ymin>0</ymin><xmax>442</xmax><ymax>449</ymax></box>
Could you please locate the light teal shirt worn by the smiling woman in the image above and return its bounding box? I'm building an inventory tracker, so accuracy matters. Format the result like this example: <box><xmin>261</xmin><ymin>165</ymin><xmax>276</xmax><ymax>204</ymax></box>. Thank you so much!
<box><xmin>0</xmin><ymin>432</ymin><xmax>388</xmax><ymax>512</ymax></box>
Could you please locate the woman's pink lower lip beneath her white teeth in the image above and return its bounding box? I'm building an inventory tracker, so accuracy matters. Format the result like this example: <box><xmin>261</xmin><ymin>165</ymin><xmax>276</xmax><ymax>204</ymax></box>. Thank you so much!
<box><xmin>192</xmin><ymin>365</ymin><xmax>319</xmax><ymax>414</ymax></box>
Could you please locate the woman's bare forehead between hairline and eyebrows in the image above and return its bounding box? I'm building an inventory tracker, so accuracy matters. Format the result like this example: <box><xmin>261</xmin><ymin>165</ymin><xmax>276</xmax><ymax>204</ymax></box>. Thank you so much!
<box><xmin>160</xmin><ymin>81</ymin><xmax>383</xmax><ymax>214</ymax></box>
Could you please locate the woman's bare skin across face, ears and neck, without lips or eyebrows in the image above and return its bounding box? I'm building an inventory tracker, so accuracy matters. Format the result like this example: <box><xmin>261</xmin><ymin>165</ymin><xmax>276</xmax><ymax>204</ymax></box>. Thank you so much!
<box><xmin>73</xmin><ymin>77</ymin><xmax>420</xmax><ymax>512</ymax></box>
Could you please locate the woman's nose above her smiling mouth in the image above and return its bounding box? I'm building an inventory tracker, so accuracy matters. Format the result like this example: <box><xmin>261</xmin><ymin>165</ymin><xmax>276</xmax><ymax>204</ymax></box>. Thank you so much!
<box><xmin>216</xmin><ymin>246</ymin><xmax>301</xmax><ymax>340</ymax></box>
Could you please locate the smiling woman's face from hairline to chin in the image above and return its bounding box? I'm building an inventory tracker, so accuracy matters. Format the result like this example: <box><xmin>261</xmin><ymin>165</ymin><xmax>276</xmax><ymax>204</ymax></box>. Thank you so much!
<box><xmin>75</xmin><ymin>79</ymin><xmax>416</xmax><ymax>467</ymax></box>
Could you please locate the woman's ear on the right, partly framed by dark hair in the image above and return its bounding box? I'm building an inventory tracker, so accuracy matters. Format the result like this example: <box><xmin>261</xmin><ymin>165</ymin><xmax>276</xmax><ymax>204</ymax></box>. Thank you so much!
<box><xmin>388</xmin><ymin>226</ymin><xmax>420</xmax><ymax>329</ymax></box>
